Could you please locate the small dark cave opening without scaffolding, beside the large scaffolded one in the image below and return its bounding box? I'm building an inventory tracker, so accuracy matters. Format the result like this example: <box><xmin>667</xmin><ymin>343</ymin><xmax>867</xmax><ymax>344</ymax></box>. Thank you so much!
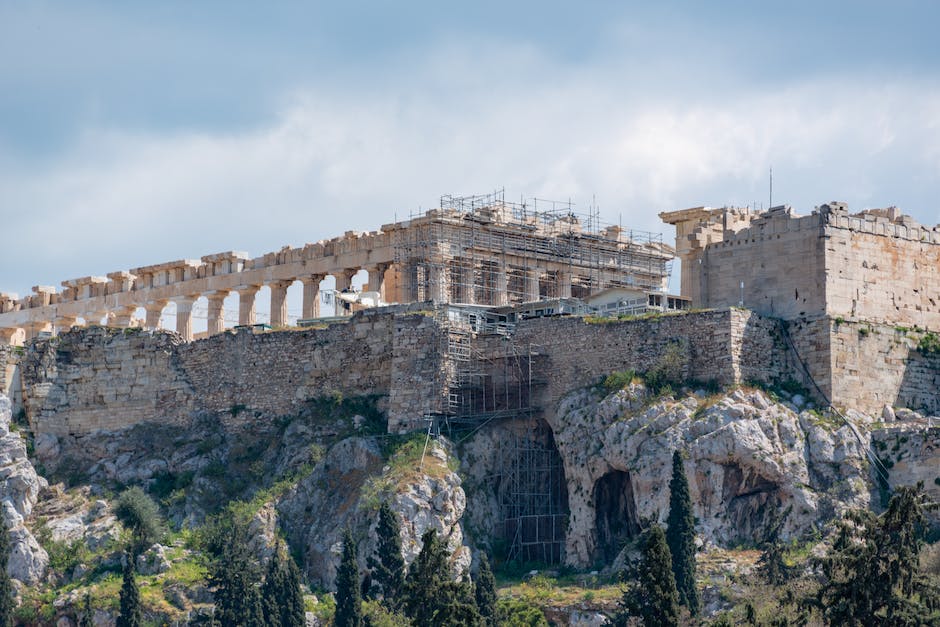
<box><xmin>594</xmin><ymin>470</ymin><xmax>640</xmax><ymax>563</ymax></box>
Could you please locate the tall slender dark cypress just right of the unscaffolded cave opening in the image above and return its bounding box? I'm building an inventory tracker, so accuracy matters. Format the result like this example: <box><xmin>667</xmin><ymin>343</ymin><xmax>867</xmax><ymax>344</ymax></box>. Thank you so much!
<box><xmin>666</xmin><ymin>451</ymin><xmax>699</xmax><ymax>616</ymax></box>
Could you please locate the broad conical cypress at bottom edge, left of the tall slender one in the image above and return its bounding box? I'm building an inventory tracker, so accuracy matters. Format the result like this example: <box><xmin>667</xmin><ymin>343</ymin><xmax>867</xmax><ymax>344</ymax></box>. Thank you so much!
<box><xmin>615</xmin><ymin>525</ymin><xmax>679</xmax><ymax>627</ymax></box>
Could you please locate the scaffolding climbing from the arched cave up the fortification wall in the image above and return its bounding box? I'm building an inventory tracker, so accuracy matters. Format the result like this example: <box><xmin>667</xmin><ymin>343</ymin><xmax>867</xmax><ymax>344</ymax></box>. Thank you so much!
<box><xmin>428</xmin><ymin>305</ymin><xmax>568</xmax><ymax>564</ymax></box>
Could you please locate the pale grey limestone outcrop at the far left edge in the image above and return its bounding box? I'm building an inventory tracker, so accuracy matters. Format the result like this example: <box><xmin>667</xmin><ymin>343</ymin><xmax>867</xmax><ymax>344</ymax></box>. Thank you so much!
<box><xmin>0</xmin><ymin>395</ymin><xmax>49</xmax><ymax>585</ymax></box>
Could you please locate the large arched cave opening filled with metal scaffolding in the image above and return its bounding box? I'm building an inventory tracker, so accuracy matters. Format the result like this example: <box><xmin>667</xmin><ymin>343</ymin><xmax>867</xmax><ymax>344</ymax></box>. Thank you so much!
<box><xmin>496</xmin><ymin>421</ymin><xmax>568</xmax><ymax>564</ymax></box>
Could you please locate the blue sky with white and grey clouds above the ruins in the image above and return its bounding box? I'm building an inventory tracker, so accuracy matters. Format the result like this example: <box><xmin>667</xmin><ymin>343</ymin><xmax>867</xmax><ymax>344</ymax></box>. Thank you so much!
<box><xmin>0</xmin><ymin>0</ymin><xmax>940</xmax><ymax>318</ymax></box>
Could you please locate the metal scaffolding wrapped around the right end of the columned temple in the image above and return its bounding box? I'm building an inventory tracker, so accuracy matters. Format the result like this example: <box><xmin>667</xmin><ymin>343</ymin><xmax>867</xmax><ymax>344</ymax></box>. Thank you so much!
<box><xmin>394</xmin><ymin>190</ymin><xmax>673</xmax><ymax>306</ymax></box>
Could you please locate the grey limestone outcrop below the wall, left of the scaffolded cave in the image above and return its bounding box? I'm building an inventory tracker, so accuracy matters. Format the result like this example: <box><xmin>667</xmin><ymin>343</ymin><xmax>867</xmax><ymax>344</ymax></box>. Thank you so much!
<box><xmin>277</xmin><ymin>438</ymin><xmax>470</xmax><ymax>588</ymax></box>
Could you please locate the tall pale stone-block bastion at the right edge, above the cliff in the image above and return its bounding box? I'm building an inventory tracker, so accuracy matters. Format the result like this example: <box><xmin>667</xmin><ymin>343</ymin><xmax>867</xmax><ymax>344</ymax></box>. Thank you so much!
<box><xmin>660</xmin><ymin>203</ymin><xmax>940</xmax><ymax>413</ymax></box>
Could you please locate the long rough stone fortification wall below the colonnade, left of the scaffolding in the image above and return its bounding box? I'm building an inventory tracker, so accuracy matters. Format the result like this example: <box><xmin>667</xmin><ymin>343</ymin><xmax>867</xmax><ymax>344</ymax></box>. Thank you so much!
<box><xmin>22</xmin><ymin>311</ymin><xmax>441</xmax><ymax>435</ymax></box>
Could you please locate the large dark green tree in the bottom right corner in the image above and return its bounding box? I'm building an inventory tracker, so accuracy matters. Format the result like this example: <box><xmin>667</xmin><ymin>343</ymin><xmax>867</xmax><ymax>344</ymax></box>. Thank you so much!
<box><xmin>816</xmin><ymin>484</ymin><xmax>940</xmax><ymax>626</ymax></box>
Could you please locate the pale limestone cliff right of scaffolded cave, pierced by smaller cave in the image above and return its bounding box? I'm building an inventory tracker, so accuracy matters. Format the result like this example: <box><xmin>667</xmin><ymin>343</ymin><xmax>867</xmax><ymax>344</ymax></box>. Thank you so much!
<box><xmin>551</xmin><ymin>386</ymin><xmax>870</xmax><ymax>565</ymax></box>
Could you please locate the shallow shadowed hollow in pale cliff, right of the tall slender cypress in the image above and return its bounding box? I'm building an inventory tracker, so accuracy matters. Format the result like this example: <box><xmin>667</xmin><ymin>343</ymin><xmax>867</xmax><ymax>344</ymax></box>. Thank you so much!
<box><xmin>722</xmin><ymin>464</ymin><xmax>781</xmax><ymax>543</ymax></box>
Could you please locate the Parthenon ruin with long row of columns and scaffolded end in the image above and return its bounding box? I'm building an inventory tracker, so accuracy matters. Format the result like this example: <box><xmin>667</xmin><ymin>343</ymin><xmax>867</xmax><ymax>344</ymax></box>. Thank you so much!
<box><xmin>0</xmin><ymin>192</ymin><xmax>674</xmax><ymax>343</ymax></box>
